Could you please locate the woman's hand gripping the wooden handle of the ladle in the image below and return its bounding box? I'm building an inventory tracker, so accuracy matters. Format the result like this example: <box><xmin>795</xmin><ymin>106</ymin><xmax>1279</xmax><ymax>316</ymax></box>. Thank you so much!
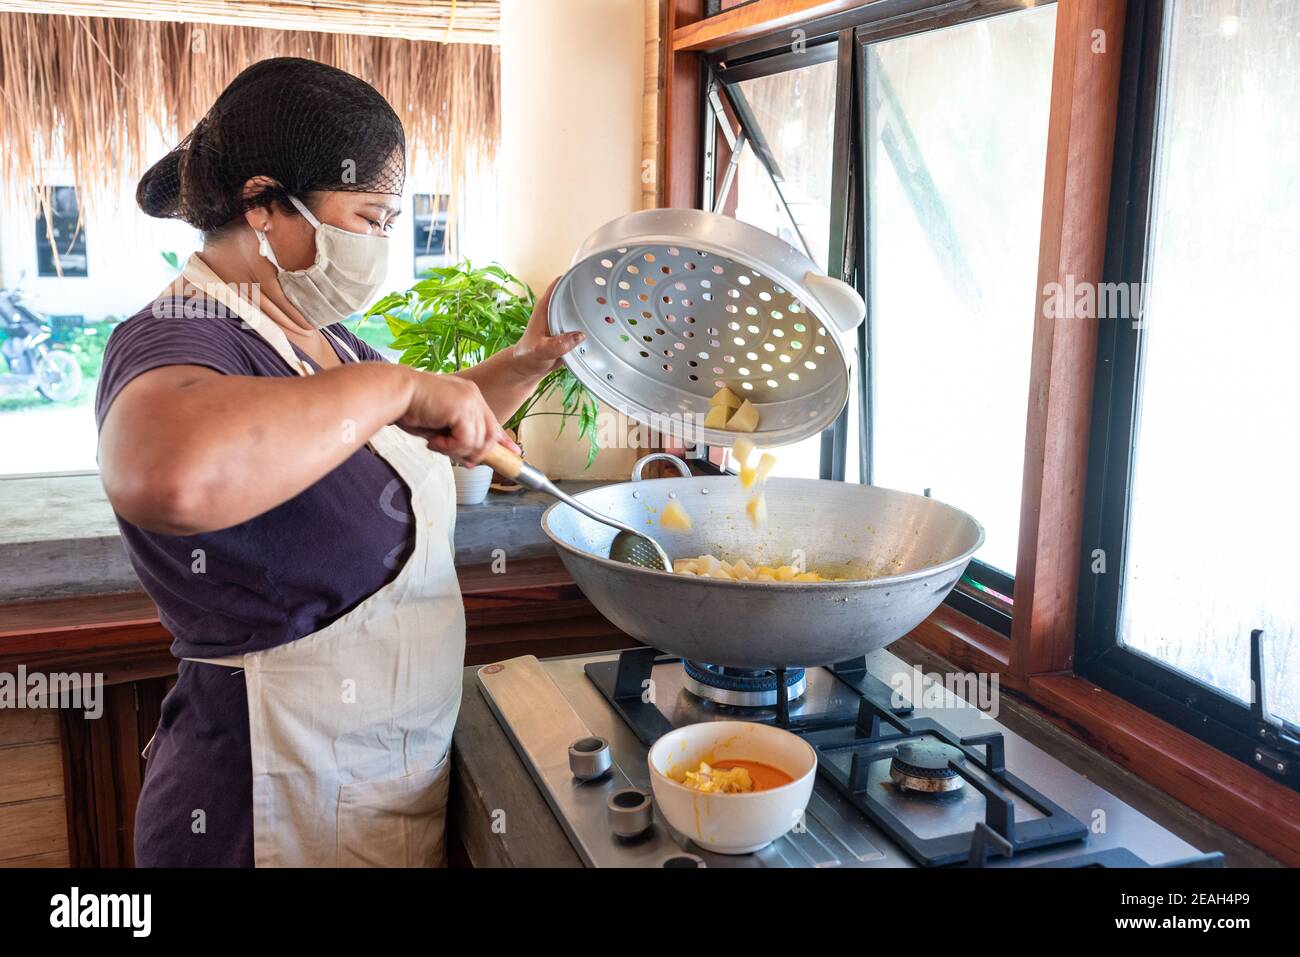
<box><xmin>397</xmin><ymin>369</ymin><xmax>519</xmax><ymax>465</ymax></box>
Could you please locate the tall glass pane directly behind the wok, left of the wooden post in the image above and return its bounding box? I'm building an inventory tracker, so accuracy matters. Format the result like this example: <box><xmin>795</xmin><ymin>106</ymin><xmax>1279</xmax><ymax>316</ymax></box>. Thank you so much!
<box><xmin>865</xmin><ymin>5</ymin><xmax>1056</xmax><ymax>573</ymax></box>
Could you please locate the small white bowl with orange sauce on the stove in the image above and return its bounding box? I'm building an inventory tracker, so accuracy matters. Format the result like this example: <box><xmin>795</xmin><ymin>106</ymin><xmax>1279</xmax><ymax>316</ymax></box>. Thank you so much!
<box><xmin>647</xmin><ymin>722</ymin><xmax>816</xmax><ymax>854</ymax></box>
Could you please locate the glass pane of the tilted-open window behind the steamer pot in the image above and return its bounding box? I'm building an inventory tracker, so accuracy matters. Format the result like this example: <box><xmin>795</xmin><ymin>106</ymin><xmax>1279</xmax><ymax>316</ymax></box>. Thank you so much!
<box><xmin>718</xmin><ymin>60</ymin><xmax>837</xmax><ymax>479</ymax></box>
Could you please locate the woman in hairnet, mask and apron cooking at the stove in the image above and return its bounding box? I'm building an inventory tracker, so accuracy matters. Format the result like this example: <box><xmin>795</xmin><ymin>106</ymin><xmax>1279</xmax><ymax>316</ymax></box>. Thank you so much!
<box><xmin>104</xmin><ymin>59</ymin><xmax>580</xmax><ymax>866</ymax></box>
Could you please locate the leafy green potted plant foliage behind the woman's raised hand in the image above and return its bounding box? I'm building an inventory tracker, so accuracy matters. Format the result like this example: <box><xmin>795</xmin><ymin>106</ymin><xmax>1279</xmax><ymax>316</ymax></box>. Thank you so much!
<box><xmin>364</xmin><ymin>260</ymin><xmax>601</xmax><ymax>467</ymax></box>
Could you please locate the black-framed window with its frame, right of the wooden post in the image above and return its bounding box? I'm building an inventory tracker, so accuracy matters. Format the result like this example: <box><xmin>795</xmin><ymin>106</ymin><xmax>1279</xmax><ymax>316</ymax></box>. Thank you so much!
<box><xmin>1080</xmin><ymin>0</ymin><xmax>1300</xmax><ymax>780</ymax></box>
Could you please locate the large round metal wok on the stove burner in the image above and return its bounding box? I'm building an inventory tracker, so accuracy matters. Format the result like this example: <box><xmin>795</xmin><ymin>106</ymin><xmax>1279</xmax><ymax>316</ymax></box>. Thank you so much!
<box><xmin>542</xmin><ymin>456</ymin><xmax>984</xmax><ymax>668</ymax></box>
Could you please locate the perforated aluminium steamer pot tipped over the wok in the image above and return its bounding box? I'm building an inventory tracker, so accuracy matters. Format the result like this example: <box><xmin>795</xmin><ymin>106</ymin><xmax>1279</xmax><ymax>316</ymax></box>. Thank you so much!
<box><xmin>549</xmin><ymin>209</ymin><xmax>866</xmax><ymax>446</ymax></box>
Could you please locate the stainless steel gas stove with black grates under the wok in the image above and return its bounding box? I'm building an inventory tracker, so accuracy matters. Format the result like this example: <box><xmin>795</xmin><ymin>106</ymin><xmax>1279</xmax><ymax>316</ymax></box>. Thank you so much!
<box><xmin>478</xmin><ymin>648</ymin><xmax>1222</xmax><ymax>867</ymax></box>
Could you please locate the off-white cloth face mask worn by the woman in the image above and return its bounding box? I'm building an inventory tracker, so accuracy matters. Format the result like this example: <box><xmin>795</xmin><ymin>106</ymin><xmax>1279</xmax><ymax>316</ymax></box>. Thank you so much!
<box><xmin>254</xmin><ymin>196</ymin><xmax>389</xmax><ymax>329</ymax></box>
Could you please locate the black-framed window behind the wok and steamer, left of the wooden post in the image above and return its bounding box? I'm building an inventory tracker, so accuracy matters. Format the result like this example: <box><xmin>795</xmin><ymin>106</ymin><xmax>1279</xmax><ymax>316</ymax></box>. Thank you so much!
<box><xmin>706</xmin><ymin>0</ymin><xmax>1056</xmax><ymax>633</ymax></box>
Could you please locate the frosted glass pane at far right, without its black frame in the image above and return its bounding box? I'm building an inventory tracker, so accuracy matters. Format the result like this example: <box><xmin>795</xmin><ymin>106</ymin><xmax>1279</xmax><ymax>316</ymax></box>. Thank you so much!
<box><xmin>1121</xmin><ymin>0</ymin><xmax>1300</xmax><ymax>723</ymax></box>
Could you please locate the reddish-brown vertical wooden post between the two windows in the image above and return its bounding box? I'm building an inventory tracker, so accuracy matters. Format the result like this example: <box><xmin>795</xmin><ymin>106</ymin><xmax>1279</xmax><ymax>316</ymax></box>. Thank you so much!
<box><xmin>1010</xmin><ymin>0</ymin><xmax>1125</xmax><ymax>677</ymax></box>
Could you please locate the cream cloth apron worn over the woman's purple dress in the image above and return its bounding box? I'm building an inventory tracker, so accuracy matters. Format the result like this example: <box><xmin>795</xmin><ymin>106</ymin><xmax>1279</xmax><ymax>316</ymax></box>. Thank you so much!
<box><xmin>175</xmin><ymin>256</ymin><xmax>465</xmax><ymax>867</ymax></box>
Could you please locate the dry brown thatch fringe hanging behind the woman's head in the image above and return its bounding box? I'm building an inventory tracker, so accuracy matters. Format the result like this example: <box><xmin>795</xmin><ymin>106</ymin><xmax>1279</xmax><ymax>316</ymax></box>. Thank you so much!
<box><xmin>0</xmin><ymin>11</ymin><xmax>501</xmax><ymax>217</ymax></box>
